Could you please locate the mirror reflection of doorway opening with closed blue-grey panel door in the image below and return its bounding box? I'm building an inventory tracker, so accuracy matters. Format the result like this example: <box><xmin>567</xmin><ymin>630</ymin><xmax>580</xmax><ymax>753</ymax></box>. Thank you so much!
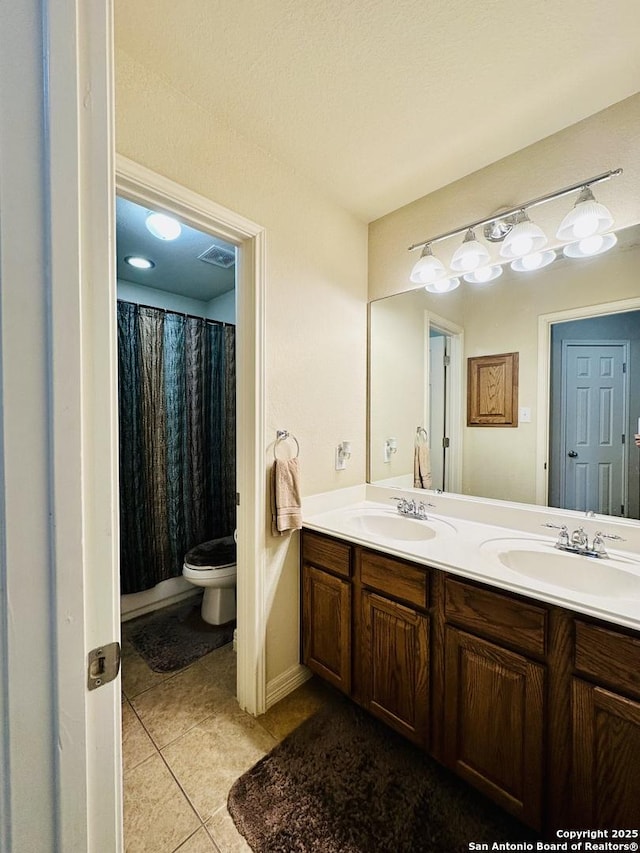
<box><xmin>549</xmin><ymin>311</ymin><xmax>640</xmax><ymax>518</ymax></box>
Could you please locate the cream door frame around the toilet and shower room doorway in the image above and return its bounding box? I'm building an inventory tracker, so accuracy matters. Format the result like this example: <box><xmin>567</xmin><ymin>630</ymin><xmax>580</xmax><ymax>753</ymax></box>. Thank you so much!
<box><xmin>114</xmin><ymin>155</ymin><xmax>266</xmax><ymax>715</ymax></box>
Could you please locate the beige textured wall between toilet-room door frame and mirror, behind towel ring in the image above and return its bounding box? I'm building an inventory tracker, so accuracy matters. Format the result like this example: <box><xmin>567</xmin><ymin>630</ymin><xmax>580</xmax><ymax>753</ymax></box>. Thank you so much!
<box><xmin>116</xmin><ymin>50</ymin><xmax>367</xmax><ymax>680</ymax></box>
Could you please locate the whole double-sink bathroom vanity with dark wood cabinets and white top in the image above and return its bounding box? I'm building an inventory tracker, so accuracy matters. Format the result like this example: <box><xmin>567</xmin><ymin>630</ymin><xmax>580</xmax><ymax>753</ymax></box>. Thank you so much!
<box><xmin>301</xmin><ymin>496</ymin><xmax>640</xmax><ymax>835</ymax></box>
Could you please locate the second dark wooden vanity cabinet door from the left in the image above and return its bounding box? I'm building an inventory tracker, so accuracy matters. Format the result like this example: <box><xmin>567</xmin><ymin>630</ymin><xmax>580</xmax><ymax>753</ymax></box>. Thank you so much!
<box><xmin>361</xmin><ymin>591</ymin><xmax>429</xmax><ymax>746</ymax></box>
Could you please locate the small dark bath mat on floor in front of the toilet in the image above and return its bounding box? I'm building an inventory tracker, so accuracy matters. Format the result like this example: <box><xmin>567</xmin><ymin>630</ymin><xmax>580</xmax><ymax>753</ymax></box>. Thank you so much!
<box><xmin>123</xmin><ymin>604</ymin><xmax>236</xmax><ymax>672</ymax></box>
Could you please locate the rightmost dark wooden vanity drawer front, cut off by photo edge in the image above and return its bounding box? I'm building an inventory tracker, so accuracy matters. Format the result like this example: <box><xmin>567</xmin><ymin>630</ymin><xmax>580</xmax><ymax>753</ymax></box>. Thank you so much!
<box><xmin>575</xmin><ymin>620</ymin><xmax>640</xmax><ymax>696</ymax></box>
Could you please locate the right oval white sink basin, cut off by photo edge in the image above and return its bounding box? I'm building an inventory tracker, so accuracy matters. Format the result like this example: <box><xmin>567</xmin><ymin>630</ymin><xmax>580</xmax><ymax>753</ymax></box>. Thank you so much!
<box><xmin>481</xmin><ymin>539</ymin><xmax>640</xmax><ymax>599</ymax></box>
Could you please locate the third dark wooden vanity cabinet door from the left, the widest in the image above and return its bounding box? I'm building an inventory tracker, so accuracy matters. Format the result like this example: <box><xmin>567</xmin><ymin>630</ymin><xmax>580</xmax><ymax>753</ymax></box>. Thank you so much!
<box><xmin>444</xmin><ymin>627</ymin><xmax>545</xmax><ymax>829</ymax></box>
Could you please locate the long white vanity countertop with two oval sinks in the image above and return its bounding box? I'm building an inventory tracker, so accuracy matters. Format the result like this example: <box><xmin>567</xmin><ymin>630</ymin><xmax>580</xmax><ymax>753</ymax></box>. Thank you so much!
<box><xmin>303</xmin><ymin>486</ymin><xmax>640</xmax><ymax>630</ymax></box>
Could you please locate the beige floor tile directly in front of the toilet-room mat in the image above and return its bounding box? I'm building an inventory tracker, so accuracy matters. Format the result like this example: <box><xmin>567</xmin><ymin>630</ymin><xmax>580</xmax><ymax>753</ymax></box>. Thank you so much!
<box><xmin>131</xmin><ymin>661</ymin><xmax>229</xmax><ymax>747</ymax></box>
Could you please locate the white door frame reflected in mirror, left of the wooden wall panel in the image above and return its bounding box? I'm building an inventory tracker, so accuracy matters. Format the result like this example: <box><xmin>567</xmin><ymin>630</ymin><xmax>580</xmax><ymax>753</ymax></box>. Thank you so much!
<box><xmin>423</xmin><ymin>310</ymin><xmax>467</xmax><ymax>494</ymax></box>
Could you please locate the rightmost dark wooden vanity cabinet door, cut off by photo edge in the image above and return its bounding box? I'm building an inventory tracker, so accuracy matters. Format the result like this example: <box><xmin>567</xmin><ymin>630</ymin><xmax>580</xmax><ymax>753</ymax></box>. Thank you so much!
<box><xmin>572</xmin><ymin>678</ymin><xmax>640</xmax><ymax>829</ymax></box>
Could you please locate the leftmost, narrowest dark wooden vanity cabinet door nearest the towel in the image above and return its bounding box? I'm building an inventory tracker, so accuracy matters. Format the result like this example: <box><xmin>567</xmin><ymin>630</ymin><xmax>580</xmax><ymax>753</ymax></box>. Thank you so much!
<box><xmin>302</xmin><ymin>565</ymin><xmax>351</xmax><ymax>694</ymax></box>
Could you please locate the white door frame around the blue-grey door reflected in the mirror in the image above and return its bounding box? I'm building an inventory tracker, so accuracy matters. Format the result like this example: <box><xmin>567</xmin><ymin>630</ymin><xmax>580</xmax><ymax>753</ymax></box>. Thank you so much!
<box><xmin>536</xmin><ymin>297</ymin><xmax>640</xmax><ymax>506</ymax></box>
